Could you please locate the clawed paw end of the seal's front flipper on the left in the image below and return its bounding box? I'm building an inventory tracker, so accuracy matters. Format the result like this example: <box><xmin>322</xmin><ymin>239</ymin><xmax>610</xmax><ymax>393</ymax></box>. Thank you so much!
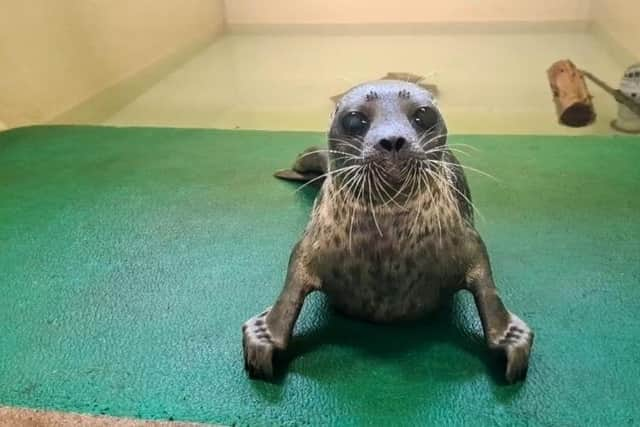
<box><xmin>242</xmin><ymin>310</ymin><xmax>276</xmax><ymax>379</ymax></box>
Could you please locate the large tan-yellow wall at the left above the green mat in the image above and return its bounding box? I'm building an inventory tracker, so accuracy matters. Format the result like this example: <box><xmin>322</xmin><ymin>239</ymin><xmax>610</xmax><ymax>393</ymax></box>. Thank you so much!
<box><xmin>0</xmin><ymin>0</ymin><xmax>224</xmax><ymax>127</ymax></box>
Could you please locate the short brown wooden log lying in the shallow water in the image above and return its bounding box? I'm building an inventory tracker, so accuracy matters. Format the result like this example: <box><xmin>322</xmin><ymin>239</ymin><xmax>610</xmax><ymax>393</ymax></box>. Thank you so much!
<box><xmin>547</xmin><ymin>59</ymin><xmax>596</xmax><ymax>127</ymax></box>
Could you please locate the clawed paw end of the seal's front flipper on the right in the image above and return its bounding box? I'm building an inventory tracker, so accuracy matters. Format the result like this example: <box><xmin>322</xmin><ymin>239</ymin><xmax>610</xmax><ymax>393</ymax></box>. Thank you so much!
<box><xmin>489</xmin><ymin>314</ymin><xmax>533</xmax><ymax>384</ymax></box>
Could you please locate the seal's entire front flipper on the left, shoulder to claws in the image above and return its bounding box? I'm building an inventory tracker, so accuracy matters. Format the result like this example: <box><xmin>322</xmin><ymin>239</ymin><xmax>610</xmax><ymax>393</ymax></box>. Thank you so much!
<box><xmin>242</xmin><ymin>244</ymin><xmax>320</xmax><ymax>379</ymax></box>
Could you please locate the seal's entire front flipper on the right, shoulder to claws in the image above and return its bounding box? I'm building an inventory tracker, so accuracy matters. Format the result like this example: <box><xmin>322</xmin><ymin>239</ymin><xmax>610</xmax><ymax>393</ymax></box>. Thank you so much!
<box><xmin>467</xmin><ymin>252</ymin><xmax>533</xmax><ymax>383</ymax></box>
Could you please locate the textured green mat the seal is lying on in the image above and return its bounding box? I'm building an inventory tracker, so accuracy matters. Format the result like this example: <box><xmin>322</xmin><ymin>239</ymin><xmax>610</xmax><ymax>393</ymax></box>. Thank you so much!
<box><xmin>0</xmin><ymin>127</ymin><xmax>640</xmax><ymax>426</ymax></box>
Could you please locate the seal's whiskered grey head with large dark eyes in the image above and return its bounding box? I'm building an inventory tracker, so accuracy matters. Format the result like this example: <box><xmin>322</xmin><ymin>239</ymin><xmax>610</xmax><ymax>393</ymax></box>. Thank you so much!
<box><xmin>329</xmin><ymin>80</ymin><xmax>447</xmax><ymax>204</ymax></box>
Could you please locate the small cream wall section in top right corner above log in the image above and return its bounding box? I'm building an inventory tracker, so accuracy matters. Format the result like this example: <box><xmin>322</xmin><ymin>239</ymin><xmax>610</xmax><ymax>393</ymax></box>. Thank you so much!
<box><xmin>592</xmin><ymin>0</ymin><xmax>640</xmax><ymax>61</ymax></box>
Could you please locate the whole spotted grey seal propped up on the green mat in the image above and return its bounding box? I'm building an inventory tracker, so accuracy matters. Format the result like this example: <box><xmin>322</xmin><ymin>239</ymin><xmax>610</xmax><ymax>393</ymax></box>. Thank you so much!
<box><xmin>242</xmin><ymin>80</ymin><xmax>534</xmax><ymax>383</ymax></box>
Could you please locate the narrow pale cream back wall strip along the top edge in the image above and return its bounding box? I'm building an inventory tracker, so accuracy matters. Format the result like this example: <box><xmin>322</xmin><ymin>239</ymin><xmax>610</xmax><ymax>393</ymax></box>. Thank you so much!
<box><xmin>225</xmin><ymin>0</ymin><xmax>592</xmax><ymax>25</ymax></box>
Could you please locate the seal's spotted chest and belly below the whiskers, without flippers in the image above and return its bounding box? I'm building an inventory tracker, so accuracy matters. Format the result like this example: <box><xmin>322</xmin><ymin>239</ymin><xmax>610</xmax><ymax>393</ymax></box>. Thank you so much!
<box><xmin>302</xmin><ymin>169</ymin><xmax>466</xmax><ymax>322</ymax></box>
